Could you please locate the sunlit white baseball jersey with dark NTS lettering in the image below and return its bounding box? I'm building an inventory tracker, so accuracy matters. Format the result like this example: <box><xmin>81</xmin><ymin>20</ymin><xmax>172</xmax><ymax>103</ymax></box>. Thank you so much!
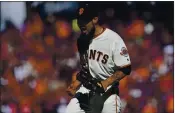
<box><xmin>88</xmin><ymin>28</ymin><xmax>131</xmax><ymax>80</ymax></box>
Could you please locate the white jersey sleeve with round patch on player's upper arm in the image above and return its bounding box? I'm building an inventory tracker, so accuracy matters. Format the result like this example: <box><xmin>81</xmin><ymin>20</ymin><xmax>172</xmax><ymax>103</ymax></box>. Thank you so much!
<box><xmin>112</xmin><ymin>38</ymin><xmax>131</xmax><ymax>68</ymax></box>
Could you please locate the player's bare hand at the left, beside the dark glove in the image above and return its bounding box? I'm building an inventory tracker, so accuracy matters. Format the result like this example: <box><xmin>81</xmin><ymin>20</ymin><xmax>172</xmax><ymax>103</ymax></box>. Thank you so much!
<box><xmin>66</xmin><ymin>80</ymin><xmax>81</xmax><ymax>96</ymax></box>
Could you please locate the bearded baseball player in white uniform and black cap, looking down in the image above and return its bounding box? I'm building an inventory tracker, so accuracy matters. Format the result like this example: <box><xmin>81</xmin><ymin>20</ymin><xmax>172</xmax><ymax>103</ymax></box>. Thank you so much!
<box><xmin>66</xmin><ymin>5</ymin><xmax>131</xmax><ymax>113</ymax></box>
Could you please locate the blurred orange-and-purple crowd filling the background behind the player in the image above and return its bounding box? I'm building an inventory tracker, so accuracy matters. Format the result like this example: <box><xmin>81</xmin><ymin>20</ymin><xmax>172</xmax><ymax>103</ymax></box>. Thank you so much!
<box><xmin>0</xmin><ymin>1</ymin><xmax>174</xmax><ymax>113</ymax></box>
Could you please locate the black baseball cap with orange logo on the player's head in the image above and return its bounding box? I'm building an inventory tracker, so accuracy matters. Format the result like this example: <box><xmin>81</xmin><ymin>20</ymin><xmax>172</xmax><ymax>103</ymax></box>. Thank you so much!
<box><xmin>77</xmin><ymin>3</ymin><xmax>99</xmax><ymax>24</ymax></box>
